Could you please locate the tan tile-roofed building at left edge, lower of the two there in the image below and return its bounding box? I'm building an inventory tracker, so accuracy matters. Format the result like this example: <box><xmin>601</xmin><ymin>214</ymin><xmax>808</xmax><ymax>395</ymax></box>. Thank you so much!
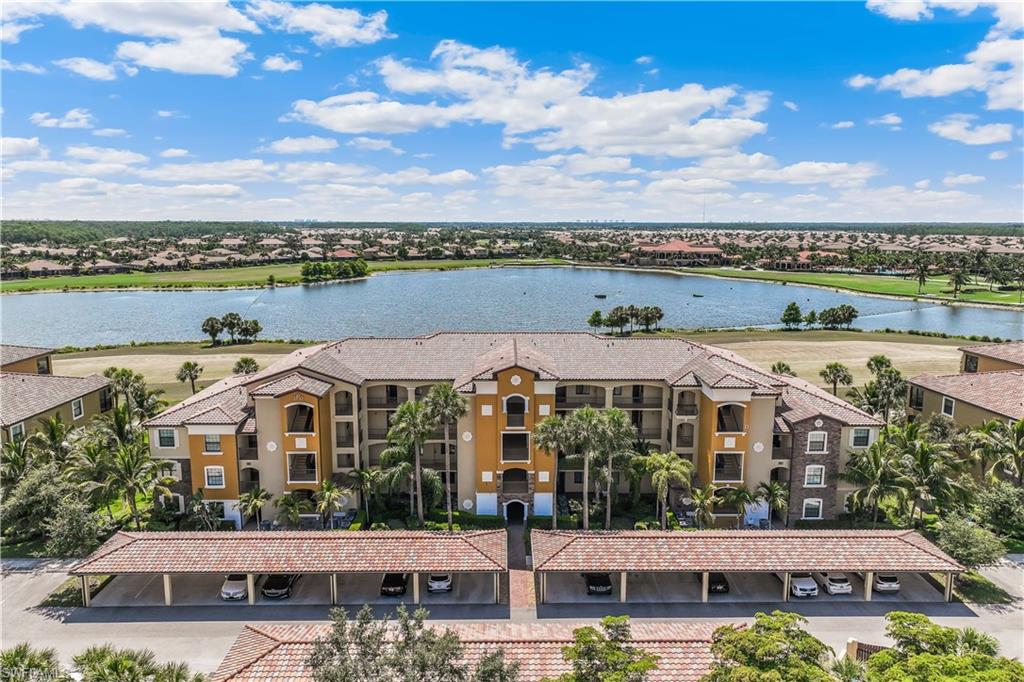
<box><xmin>0</xmin><ymin>372</ymin><xmax>114</xmax><ymax>442</ymax></box>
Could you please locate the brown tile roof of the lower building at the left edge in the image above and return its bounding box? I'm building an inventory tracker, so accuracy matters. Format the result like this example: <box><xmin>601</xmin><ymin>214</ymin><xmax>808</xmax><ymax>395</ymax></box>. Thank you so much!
<box><xmin>0</xmin><ymin>372</ymin><xmax>111</xmax><ymax>426</ymax></box>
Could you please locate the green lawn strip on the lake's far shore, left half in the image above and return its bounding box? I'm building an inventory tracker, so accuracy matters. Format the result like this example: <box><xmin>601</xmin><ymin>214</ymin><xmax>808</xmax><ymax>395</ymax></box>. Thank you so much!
<box><xmin>0</xmin><ymin>258</ymin><xmax>561</xmax><ymax>292</ymax></box>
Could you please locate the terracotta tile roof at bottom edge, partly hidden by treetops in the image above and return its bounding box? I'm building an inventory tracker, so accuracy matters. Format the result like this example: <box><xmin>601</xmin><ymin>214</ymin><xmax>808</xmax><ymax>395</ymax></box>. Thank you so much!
<box><xmin>210</xmin><ymin>622</ymin><xmax>719</xmax><ymax>682</ymax></box>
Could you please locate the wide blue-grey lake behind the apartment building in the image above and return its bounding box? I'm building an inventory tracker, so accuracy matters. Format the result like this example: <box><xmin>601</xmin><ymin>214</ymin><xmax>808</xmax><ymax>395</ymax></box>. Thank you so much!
<box><xmin>0</xmin><ymin>267</ymin><xmax>1024</xmax><ymax>346</ymax></box>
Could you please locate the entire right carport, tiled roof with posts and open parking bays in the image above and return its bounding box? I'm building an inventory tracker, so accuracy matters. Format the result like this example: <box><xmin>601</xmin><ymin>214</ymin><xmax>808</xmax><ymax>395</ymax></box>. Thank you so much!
<box><xmin>530</xmin><ymin>529</ymin><xmax>964</xmax><ymax>603</ymax></box>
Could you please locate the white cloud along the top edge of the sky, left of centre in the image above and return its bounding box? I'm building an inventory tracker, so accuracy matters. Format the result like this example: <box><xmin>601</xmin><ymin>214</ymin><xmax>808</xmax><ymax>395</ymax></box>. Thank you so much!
<box><xmin>246</xmin><ymin>0</ymin><xmax>394</xmax><ymax>47</ymax></box>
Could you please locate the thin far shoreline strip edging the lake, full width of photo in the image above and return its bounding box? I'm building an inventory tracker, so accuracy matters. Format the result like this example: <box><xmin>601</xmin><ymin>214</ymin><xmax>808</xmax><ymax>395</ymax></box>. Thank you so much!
<box><xmin>0</xmin><ymin>261</ymin><xmax>1024</xmax><ymax>312</ymax></box>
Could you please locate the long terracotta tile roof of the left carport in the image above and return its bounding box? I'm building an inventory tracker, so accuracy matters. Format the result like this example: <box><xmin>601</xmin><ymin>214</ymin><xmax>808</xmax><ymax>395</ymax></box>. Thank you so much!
<box><xmin>70</xmin><ymin>529</ymin><xmax>508</xmax><ymax>576</ymax></box>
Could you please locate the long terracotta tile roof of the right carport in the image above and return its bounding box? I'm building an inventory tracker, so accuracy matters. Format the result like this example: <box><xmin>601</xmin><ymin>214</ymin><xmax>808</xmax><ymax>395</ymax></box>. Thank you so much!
<box><xmin>530</xmin><ymin>530</ymin><xmax>964</xmax><ymax>572</ymax></box>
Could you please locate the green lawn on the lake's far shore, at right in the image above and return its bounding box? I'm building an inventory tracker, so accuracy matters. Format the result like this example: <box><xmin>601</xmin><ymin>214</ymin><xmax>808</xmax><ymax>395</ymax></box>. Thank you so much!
<box><xmin>683</xmin><ymin>267</ymin><xmax>1020</xmax><ymax>305</ymax></box>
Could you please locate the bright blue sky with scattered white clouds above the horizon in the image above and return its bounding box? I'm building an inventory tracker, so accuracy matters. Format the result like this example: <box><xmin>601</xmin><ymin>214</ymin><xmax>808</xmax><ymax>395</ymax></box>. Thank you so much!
<box><xmin>2</xmin><ymin>0</ymin><xmax>1024</xmax><ymax>221</ymax></box>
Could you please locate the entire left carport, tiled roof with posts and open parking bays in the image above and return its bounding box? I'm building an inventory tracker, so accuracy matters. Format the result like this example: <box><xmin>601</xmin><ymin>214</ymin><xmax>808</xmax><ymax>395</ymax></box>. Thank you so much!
<box><xmin>69</xmin><ymin>529</ymin><xmax>508</xmax><ymax>606</ymax></box>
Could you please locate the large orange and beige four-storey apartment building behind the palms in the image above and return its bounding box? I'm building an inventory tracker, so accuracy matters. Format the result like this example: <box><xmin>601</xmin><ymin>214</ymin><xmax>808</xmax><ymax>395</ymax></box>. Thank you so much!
<box><xmin>145</xmin><ymin>332</ymin><xmax>881</xmax><ymax>525</ymax></box>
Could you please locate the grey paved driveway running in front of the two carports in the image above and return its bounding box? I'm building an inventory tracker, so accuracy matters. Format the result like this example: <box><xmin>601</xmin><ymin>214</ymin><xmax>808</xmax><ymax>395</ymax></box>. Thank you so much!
<box><xmin>0</xmin><ymin>556</ymin><xmax>1024</xmax><ymax>672</ymax></box>
